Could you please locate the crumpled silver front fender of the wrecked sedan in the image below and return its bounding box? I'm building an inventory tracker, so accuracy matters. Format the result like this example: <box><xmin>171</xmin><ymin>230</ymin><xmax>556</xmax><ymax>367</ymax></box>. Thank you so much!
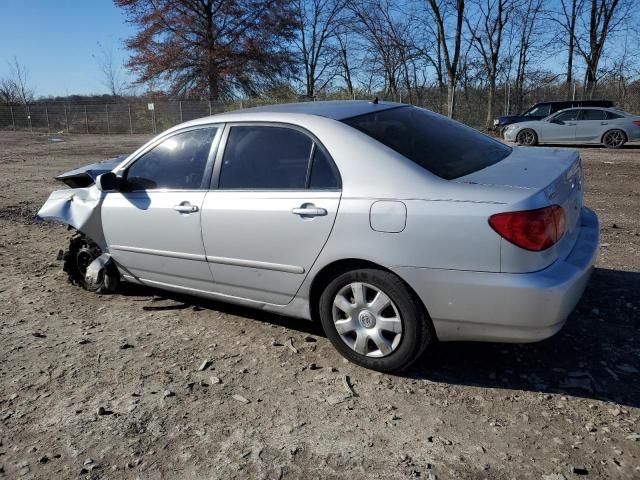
<box><xmin>37</xmin><ymin>185</ymin><xmax>107</xmax><ymax>251</ymax></box>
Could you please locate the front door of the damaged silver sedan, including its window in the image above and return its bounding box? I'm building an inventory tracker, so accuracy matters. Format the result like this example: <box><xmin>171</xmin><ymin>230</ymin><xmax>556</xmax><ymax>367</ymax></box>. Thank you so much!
<box><xmin>102</xmin><ymin>126</ymin><xmax>221</xmax><ymax>291</ymax></box>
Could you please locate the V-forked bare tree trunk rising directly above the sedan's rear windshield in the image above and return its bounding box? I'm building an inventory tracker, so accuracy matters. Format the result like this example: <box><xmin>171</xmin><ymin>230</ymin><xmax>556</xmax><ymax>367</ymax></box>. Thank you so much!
<box><xmin>427</xmin><ymin>0</ymin><xmax>465</xmax><ymax>117</ymax></box>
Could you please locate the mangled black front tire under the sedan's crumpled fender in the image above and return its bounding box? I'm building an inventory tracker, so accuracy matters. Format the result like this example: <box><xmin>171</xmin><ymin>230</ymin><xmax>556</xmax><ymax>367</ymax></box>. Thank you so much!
<box><xmin>62</xmin><ymin>233</ymin><xmax>120</xmax><ymax>294</ymax></box>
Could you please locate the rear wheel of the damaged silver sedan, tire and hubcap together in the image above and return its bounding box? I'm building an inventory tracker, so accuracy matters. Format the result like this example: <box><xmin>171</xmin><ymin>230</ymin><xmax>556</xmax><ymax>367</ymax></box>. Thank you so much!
<box><xmin>319</xmin><ymin>269</ymin><xmax>435</xmax><ymax>372</ymax></box>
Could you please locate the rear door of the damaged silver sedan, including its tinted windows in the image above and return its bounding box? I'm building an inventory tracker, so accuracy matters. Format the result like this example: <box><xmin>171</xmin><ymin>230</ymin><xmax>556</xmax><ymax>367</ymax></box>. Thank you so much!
<box><xmin>202</xmin><ymin>124</ymin><xmax>341</xmax><ymax>305</ymax></box>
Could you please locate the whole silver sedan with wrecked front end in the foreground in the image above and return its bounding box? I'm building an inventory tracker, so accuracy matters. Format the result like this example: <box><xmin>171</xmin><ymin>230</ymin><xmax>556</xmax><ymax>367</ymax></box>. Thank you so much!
<box><xmin>39</xmin><ymin>101</ymin><xmax>599</xmax><ymax>371</ymax></box>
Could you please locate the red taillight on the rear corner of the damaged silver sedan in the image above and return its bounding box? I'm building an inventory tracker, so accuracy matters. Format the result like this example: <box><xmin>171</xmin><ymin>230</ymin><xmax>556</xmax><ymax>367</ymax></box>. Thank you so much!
<box><xmin>489</xmin><ymin>205</ymin><xmax>565</xmax><ymax>252</ymax></box>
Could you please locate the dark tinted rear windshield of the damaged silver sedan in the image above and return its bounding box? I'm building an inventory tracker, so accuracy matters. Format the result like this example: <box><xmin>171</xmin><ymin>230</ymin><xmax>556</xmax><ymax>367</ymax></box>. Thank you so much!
<box><xmin>343</xmin><ymin>107</ymin><xmax>511</xmax><ymax>180</ymax></box>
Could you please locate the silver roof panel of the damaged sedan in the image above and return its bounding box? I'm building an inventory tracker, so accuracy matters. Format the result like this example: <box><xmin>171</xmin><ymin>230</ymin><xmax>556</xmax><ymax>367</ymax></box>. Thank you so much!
<box><xmin>222</xmin><ymin>100</ymin><xmax>407</xmax><ymax>120</ymax></box>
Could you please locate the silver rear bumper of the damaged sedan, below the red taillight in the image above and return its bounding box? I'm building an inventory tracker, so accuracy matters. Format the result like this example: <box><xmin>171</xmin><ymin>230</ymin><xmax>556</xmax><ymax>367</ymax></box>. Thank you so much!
<box><xmin>394</xmin><ymin>208</ymin><xmax>599</xmax><ymax>342</ymax></box>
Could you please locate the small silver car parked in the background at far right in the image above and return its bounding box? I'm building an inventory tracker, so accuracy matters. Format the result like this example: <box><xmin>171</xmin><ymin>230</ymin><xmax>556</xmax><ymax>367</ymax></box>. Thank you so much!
<box><xmin>504</xmin><ymin>107</ymin><xmax>640</xmax><ymax>148</ymax></box>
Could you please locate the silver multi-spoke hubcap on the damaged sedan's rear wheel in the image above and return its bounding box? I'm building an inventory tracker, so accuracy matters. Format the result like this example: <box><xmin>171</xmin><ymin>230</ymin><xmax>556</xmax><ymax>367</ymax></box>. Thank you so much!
<box><xmin>333</xmin><ymin>282</ymin><xmax>402</xmax><ymax>357</ymax></box>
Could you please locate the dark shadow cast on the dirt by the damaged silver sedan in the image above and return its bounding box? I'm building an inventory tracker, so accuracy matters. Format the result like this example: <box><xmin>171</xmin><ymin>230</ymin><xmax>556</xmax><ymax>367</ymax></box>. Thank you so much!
<box><xmin>123</xmin><ymin>268</ymin><xmax>640</xmax><ymax>407</ymax></box>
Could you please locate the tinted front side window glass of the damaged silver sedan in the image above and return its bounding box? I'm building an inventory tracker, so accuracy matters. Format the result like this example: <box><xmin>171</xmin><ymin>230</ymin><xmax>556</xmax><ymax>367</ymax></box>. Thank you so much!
<box><xmin>126</xmin><ymin>127</ymin><xmax>218</xmax><ymax>190</ymax></box>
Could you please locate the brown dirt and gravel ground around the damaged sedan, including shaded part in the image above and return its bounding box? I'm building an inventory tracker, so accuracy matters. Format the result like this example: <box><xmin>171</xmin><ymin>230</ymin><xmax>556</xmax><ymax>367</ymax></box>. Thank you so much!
<box><xmin>0</xmin><ymin>132</ymin><xmax>640</xmax><ymax>480</ymax></box>
